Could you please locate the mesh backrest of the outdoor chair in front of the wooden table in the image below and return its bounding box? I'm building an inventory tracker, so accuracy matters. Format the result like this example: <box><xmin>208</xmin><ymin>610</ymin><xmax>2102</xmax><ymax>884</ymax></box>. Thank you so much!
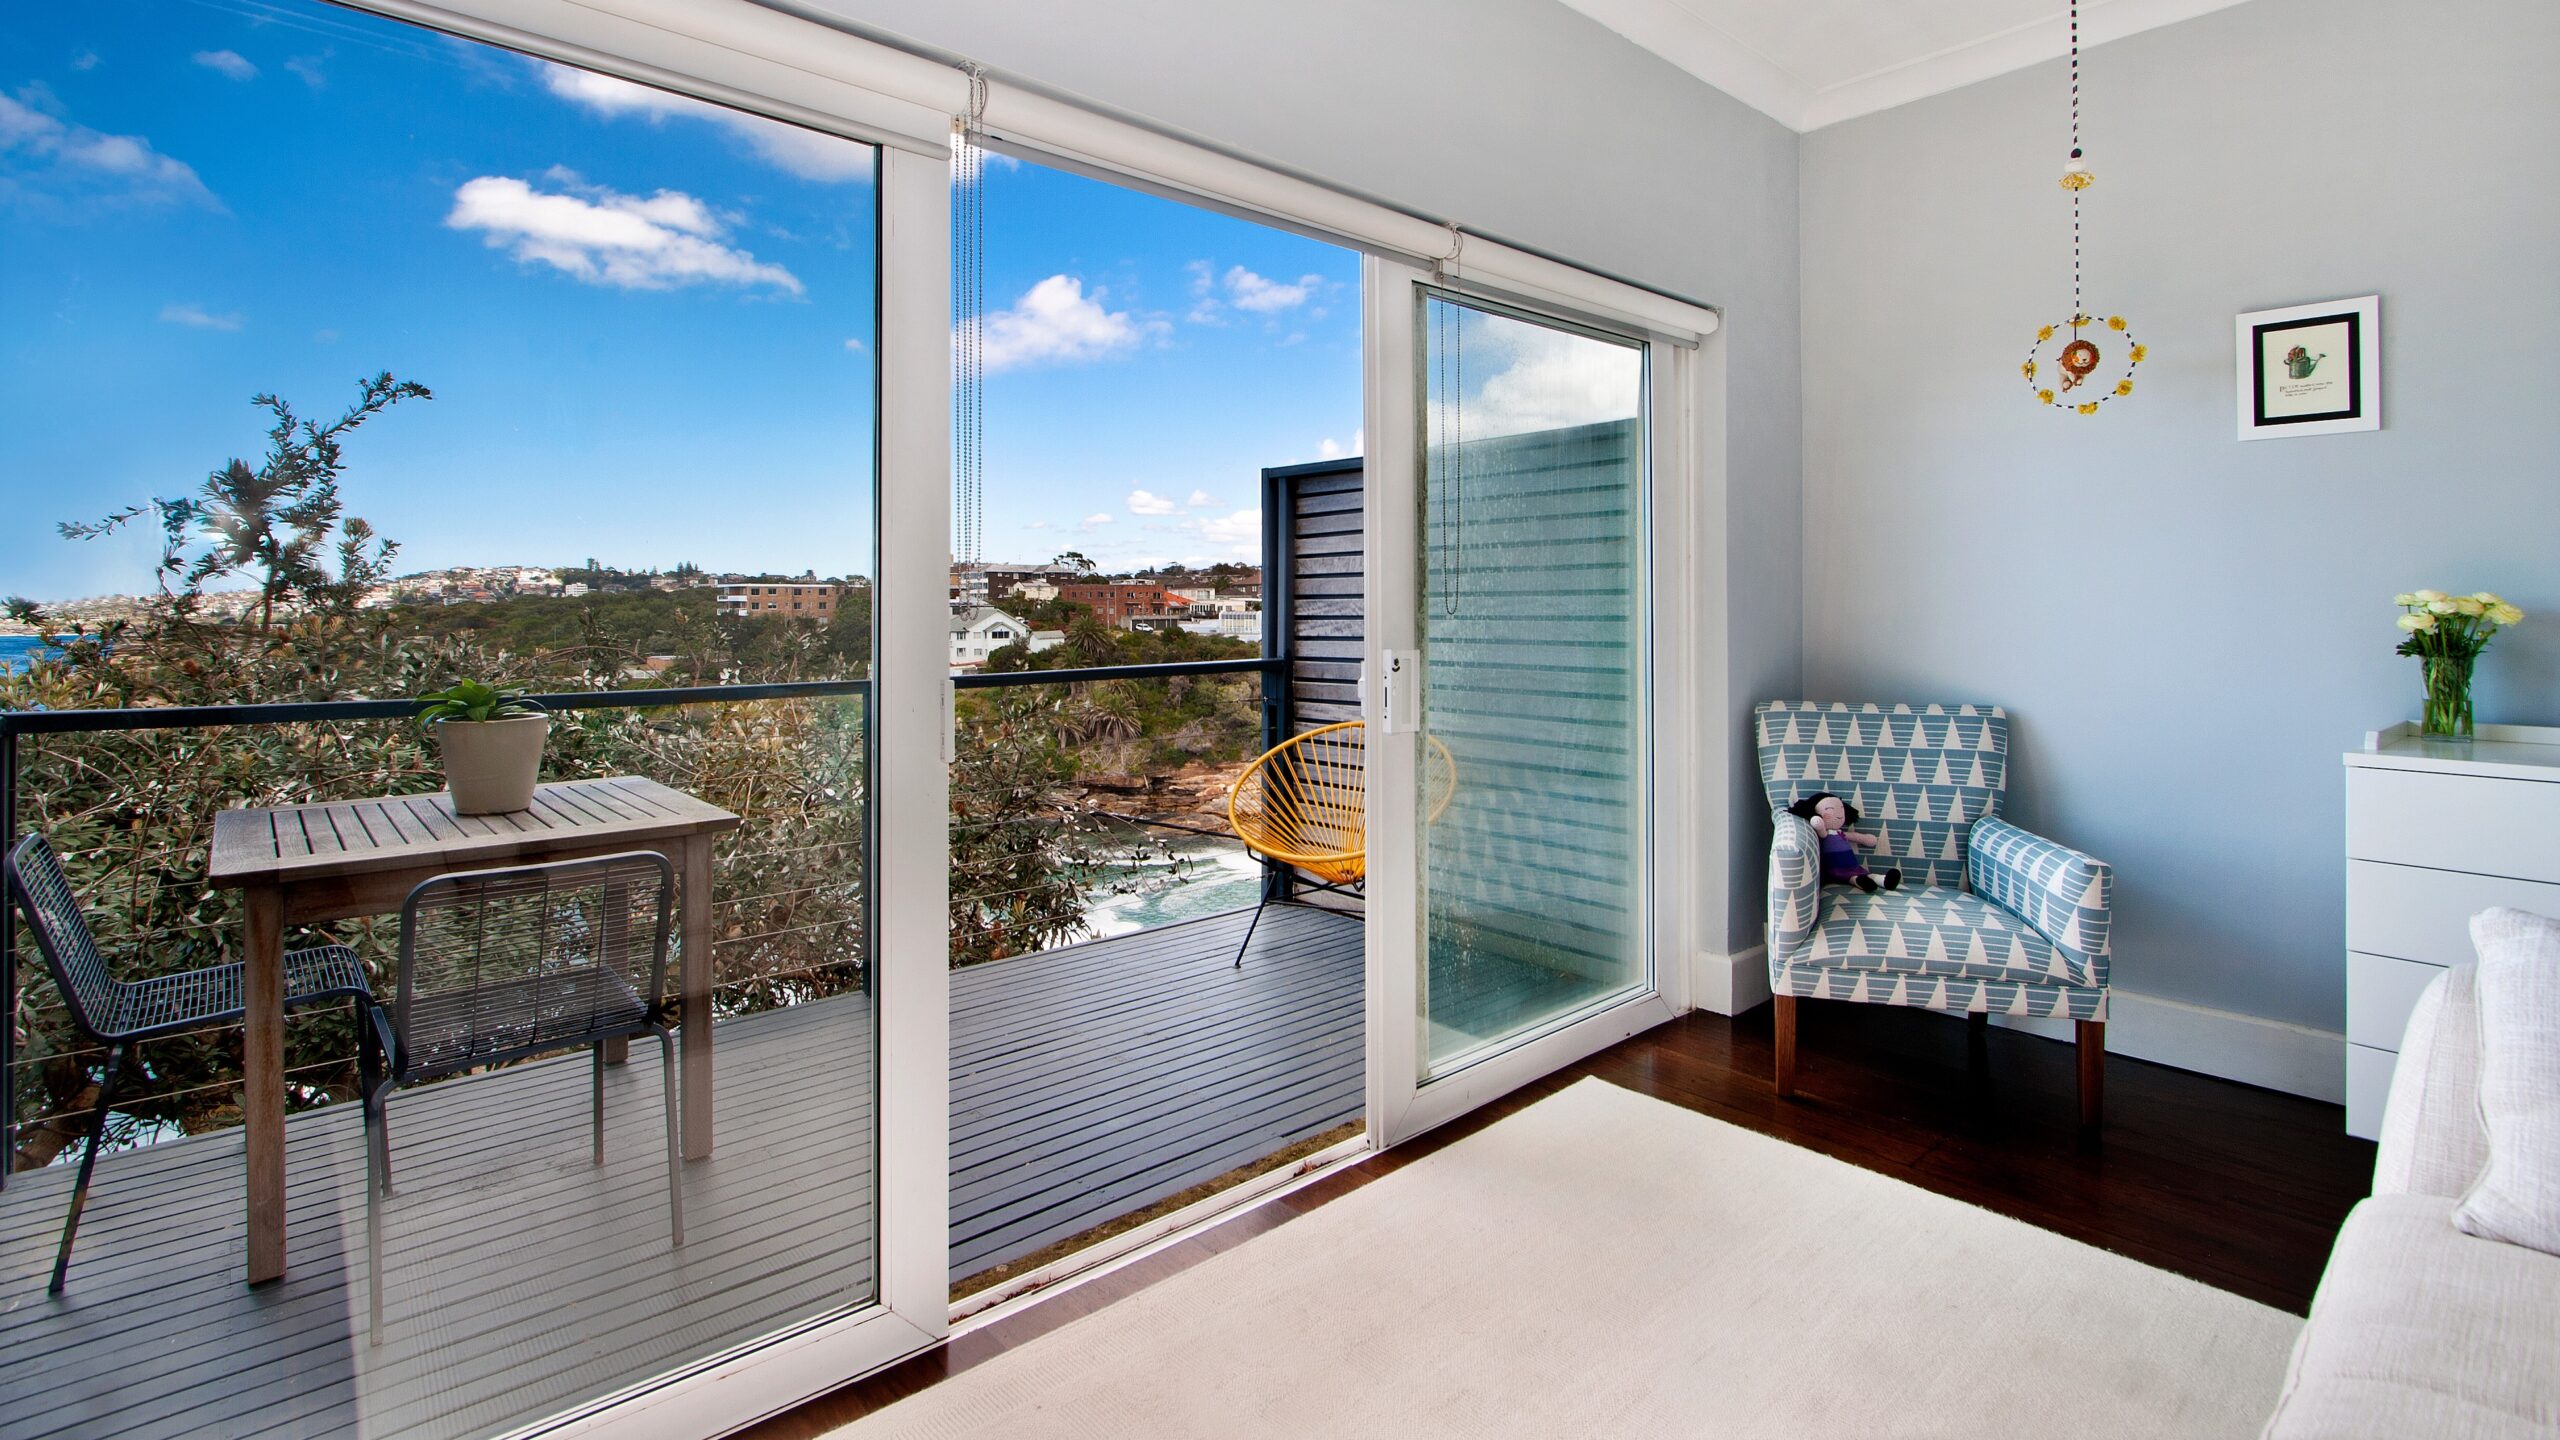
<box><xmin>392</xmin><ymin>851</ymin><xmax>670</xmax><ymax>1079</ymax></box>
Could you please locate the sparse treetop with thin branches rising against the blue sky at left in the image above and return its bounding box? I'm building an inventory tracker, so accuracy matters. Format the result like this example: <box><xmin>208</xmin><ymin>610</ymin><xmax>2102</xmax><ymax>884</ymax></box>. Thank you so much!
<box><xmin>61</xmin><ymin>372</ymin><xmax>433</xmax><ymax>635</ymax></box>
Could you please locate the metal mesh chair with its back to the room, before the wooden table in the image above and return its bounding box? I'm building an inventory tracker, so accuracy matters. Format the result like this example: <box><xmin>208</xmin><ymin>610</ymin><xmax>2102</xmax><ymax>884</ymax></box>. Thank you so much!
<box><xmin>364</xmin><ymin>851</ymin><xmax>684</xmax><ymax>1345</ymax></box>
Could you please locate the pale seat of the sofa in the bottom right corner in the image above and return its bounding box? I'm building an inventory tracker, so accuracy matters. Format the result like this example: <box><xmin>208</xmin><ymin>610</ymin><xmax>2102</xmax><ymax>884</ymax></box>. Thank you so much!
<box><xmin>2266</xmin><ymin>1194</ymin><xmax>2560</xmax><ymax>1440</ymax></box>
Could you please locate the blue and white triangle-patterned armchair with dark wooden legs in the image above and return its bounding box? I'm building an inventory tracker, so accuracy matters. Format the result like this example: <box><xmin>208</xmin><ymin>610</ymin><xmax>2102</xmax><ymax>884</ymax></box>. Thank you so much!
<box><xmin>1756</xmin><ymin>702</ymin><xmax>2115</xmax><ymax>1125</ymax></box>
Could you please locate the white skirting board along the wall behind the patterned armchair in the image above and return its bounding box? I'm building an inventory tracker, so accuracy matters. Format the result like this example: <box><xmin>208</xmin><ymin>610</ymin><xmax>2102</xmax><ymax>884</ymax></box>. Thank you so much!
<box><xmin>1690</xmin><ymin>945</ymin><xmax>2348</xmax><ymax>1104</ymax></box>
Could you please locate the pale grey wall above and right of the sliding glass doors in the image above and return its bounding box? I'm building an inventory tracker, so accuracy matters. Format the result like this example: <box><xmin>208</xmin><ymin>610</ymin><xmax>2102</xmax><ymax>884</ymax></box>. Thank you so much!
<box><xmin>799</xmin><ymin>0</ymin><xmax>1802</xmax><ymax>948</ymax></box>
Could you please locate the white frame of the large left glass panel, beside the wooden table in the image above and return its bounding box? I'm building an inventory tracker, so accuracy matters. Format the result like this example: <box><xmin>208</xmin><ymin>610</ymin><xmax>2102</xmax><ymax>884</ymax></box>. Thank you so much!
<box><xmin>351</xmin><ymin>0</ymin><xmax>952</xmax><ymax>1440</ymax></box>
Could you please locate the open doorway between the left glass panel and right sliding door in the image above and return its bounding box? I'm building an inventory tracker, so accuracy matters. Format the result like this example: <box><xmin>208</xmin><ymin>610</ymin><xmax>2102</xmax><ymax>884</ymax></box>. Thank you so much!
<box><xmin>950</xmin><ymin>154</ymin><xmax>1364</xmax><ymax>1297</ymax></box>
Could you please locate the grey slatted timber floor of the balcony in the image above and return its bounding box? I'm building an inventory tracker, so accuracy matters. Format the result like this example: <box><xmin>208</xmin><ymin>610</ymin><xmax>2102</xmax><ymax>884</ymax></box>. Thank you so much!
<box><xmin>0</xmin><ymin>907</ymin><xmax>1362</xmax><ymax>1440</ymax></box>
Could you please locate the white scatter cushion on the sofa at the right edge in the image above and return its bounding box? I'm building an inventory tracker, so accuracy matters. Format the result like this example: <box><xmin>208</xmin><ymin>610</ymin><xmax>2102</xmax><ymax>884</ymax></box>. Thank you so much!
<box><xmin>2452</xmin><ymin>907</ymin><xmax>2560</xmax><ymax>1255</ymax></box>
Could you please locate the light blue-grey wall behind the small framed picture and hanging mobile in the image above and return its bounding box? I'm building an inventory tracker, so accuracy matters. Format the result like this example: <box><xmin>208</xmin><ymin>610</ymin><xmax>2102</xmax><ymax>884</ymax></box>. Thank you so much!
<box><xmin>1802</xmin><ymin>0</ymin><xmax>2560</xmax><ymax>1030</ymax></box>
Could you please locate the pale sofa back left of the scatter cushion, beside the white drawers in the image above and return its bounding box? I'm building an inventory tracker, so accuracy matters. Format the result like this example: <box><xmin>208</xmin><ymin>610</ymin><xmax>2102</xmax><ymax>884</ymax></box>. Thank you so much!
<box><xmin>2373</xmin><ymin>966</ymin><xmax>2488</xmax><ymax>1199</ymax></box>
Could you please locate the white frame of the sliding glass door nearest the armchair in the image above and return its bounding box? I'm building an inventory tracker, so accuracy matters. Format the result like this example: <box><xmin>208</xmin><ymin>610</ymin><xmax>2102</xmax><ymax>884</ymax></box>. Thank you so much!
<box><xmin>1362</xmin><ymin>256</ymin><xmax>1702</xmax><ymax>1145</ymax></box>
